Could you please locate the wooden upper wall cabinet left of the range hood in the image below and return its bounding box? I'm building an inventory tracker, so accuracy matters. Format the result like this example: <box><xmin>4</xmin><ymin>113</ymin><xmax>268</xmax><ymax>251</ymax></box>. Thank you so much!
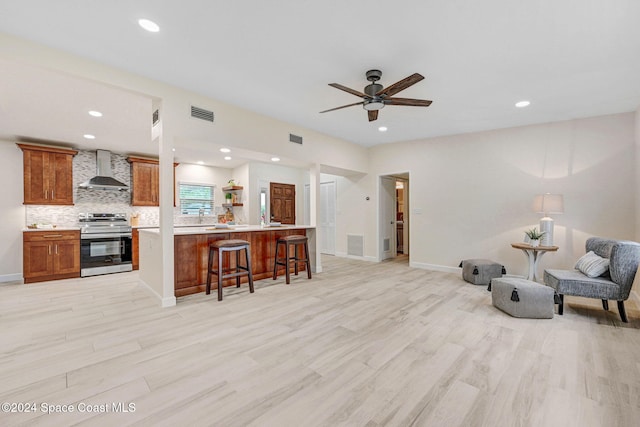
<box><xmin>17</xmin><ymin>144</ymin><xmax>78</xmax><ymax>205</ymax></box>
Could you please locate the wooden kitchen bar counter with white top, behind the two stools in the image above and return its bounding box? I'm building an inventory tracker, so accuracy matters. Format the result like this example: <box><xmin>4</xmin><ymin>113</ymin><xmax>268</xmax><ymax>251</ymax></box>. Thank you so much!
<box><xmin>139</xmin><ymin>225</ymin><xmax>315</xmax><ymax>297</ymax></box>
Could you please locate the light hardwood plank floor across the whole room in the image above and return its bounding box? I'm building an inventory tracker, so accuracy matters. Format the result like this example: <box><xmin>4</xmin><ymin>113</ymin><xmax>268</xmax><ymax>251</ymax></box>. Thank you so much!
<box><xmin>0</xmin><ymin>257</ymin><xmax>640</xmax><ymax>427</ymax></box>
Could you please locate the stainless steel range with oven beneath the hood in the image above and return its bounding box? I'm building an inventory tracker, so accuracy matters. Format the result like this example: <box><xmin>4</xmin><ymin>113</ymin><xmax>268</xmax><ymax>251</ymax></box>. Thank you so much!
<box><xmin>78</xmin><ymin>213</ymin><xmax>133</xmax><ymax>277</ymax></box>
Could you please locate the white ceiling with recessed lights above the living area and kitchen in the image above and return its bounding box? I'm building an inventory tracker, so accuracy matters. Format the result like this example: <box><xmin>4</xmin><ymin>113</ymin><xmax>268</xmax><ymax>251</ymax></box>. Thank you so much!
<box><xmin>0</xmin><ymin>0</ymin><xmax>640</xmax><ymax>160</ymax></box>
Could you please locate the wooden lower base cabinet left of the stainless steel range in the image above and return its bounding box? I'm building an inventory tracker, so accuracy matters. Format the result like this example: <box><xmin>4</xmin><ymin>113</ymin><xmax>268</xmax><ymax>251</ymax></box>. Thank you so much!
<box><xmin>22</xmin><ymin>230</ymin><xmax>80</xmax><ymax>283</ymax></box>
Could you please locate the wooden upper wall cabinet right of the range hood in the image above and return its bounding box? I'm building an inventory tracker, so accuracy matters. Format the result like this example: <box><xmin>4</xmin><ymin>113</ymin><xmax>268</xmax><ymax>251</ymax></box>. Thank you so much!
<box><xmin>127</xmin><ymin>156</ymin><xmax>178</xmax><ymax>206</ymax></box>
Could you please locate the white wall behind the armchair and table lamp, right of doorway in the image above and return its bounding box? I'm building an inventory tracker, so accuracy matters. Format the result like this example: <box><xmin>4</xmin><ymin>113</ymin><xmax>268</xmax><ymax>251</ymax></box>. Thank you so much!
<box><xmin>366</xmin><ymin>113</ymin><xmax>636</xmax><ymax>274</ymax></box>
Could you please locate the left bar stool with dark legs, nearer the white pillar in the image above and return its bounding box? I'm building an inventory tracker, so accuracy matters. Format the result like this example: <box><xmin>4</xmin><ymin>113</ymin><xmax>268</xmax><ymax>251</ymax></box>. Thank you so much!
<box><xmin>207</xmin><ymin>239</ymin><xmax>253</xmax><ymax>301</ymax></box>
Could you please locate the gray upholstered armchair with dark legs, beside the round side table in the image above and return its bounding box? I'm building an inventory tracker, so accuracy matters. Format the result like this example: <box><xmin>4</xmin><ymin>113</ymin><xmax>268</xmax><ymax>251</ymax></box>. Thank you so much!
<box><xmin>544</xmin><ymin>237</ymin><xmax>640</xmax><ymax>322</ymax></box>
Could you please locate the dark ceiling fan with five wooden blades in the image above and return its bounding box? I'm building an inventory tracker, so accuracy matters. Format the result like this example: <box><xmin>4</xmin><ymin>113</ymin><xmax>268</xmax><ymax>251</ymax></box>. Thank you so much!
<box><xmin>320</xmin><ymin>70</ymin><xmax>432</xmax><ymax>122</ymax></box>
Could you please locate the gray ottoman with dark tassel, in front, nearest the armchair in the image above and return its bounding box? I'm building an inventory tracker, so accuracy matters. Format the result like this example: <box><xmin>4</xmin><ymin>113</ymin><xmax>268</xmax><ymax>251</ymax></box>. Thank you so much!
<box><xmin>491</xmin><ymin>277</ymin><xmax>554</xmax><ymax>319</ymax></box>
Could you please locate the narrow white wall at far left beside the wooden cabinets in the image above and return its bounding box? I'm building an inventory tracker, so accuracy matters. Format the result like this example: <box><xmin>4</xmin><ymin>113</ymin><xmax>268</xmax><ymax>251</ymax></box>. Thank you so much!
<box><xmin>0</xmin><ymin>140</ymin><xmax>25</xmax><ymax>282</ymax></box>
